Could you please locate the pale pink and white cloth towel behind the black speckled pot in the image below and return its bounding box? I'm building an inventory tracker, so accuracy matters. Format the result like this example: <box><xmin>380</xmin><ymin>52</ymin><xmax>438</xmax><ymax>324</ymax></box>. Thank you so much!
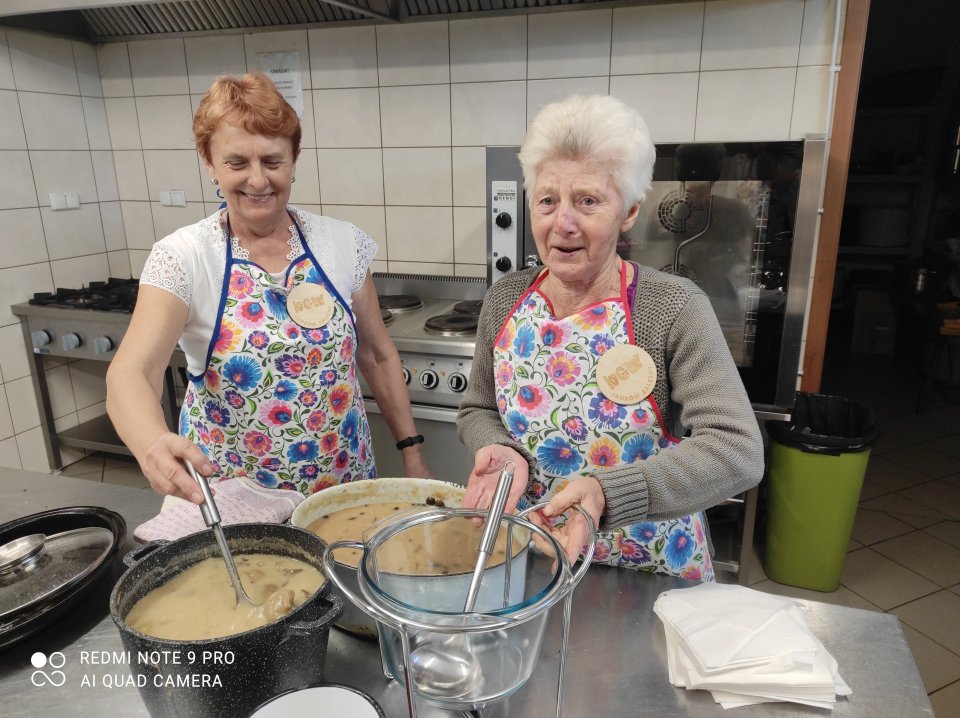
<box><xmin>133</xmin><ymin>478</ymin><xmax>305</xmax><ymax>542</ymax></box>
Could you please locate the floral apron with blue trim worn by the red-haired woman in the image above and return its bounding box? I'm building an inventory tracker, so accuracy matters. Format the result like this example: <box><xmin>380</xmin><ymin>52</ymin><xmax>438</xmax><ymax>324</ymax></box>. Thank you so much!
<box><xmin>180</xmin><ymin>212</ymin><xmax>376</xmax><ymax>494</ymax></box>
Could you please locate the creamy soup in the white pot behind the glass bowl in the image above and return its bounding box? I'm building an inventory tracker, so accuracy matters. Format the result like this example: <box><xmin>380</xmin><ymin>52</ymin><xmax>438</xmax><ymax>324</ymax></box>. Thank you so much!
<box><xmin>307</xmin><ymin>501</ymin><xmax>526</xmax><ymax>576</ymax></box>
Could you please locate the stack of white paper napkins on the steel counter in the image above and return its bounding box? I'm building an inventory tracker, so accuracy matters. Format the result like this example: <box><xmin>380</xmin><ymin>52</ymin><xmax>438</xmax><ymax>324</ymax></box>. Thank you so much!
<box><xmin>653</xmin><ymin>583</ymin><xmax>853</xmax><ymax>708</ymax></box>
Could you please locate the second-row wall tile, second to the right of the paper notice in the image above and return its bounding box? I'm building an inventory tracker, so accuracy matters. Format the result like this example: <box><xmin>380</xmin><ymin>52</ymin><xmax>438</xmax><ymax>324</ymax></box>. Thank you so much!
<box><xmin>380</xmin><ymin>85</ymin><xmax>450</xmax><ymax>147</ymax></box>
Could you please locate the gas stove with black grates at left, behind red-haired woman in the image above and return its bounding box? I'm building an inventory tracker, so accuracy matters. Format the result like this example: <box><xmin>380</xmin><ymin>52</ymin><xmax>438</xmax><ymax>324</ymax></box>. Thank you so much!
<box><xmin>10</xmin><ymin>278</ymin><xmax>185</xmax><ymax>470</ymax></box>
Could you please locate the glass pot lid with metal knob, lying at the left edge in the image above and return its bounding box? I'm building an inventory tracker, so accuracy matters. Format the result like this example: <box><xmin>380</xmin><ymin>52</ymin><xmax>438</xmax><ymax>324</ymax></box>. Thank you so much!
<box><xmin>0</xmin><ymin>526</ymin><xmax>114</xmax><ymax>619</ymax></box>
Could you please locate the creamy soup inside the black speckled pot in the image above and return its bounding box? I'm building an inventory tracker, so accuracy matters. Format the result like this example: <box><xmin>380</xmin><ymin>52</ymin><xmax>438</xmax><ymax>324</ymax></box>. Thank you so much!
<box><xmin>126</xmin><ymin>553</ymin><xmax>324</xmax><ymax>641</ymax></box>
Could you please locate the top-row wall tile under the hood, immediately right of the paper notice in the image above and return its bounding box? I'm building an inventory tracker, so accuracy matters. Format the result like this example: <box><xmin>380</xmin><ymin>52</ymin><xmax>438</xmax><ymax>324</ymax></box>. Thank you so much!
<box><xmin>307</xmin><ymin>26</ymin><xmax>378</xmax><ymax>89</ymax></box>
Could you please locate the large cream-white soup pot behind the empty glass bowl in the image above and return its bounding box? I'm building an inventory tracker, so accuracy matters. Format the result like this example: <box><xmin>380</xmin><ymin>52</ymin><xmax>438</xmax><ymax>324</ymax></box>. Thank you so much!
<box><xmin>290</xmin><ymin>478</ymin><xmax>469</xmax><ymax>638</ymax></box>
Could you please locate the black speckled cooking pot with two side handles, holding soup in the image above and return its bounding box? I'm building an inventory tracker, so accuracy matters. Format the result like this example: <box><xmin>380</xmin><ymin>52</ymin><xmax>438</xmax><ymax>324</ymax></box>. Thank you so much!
<box><xmin>110</xmin><ymin>524</ymin><xmax>343</xmax><ymax>718</ymax></box>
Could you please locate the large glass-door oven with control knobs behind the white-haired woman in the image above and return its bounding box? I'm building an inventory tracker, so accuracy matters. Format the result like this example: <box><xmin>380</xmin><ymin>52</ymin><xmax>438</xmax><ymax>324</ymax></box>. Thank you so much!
<box><xmin>486</xmin><ymin>136</ymin><xmax>826</xmax><ymax>419</ymax></box>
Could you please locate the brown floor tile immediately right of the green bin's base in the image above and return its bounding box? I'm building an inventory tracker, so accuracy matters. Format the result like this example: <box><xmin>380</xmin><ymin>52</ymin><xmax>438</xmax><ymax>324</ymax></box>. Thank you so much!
<box><xmin>841</xmin><ymin>548</ymin><xmax>939</xmax><ymax>610</ymax></box>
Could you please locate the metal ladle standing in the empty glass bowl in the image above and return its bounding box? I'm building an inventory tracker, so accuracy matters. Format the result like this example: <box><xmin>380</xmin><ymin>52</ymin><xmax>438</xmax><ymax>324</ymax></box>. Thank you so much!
<box><xmin>410</xmin><ymin>461</ymin><xmax>516</xmax><ymax>698</ymax></box>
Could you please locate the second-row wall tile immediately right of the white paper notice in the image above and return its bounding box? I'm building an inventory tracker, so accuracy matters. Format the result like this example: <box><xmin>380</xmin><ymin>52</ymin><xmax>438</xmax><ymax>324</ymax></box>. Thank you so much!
<box><xmin>313</xmin><ymin>88</ymin><xmax>381</xmax><ymax>148</ymax></box>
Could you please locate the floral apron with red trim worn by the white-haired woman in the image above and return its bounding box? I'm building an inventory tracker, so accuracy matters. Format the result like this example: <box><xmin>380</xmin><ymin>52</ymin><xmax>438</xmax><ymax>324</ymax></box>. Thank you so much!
<box><xmin>494</xmin><ymin>268</ymin><xmax>714</xmax><ymax>581</ymax></box>
